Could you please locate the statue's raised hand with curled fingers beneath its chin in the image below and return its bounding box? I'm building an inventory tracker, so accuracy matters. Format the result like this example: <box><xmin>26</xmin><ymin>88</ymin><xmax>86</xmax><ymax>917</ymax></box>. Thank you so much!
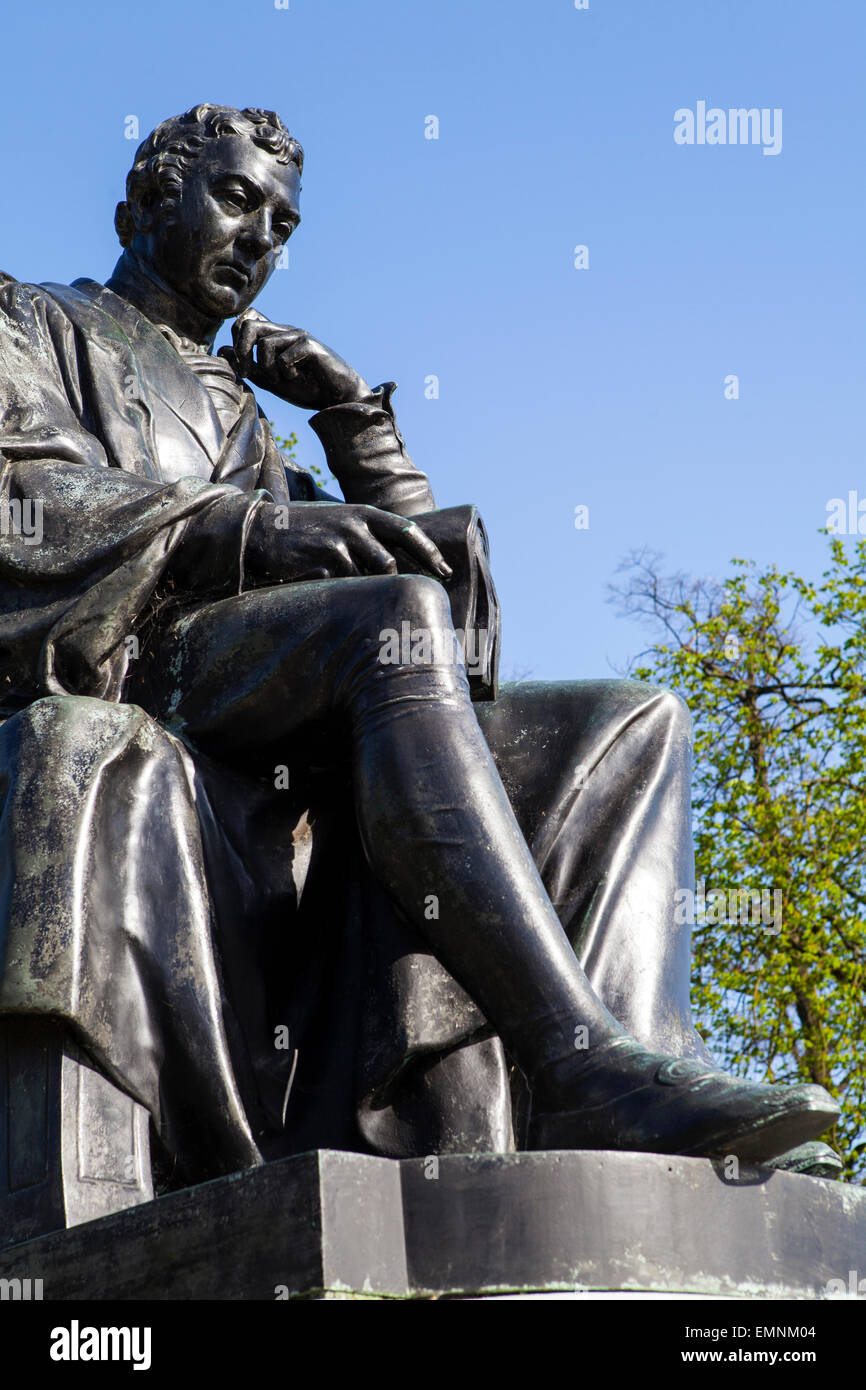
<box><xmin>220</xmin><ymin>309</ymin><xmax>370</xmax><ymax>410</ymax></box>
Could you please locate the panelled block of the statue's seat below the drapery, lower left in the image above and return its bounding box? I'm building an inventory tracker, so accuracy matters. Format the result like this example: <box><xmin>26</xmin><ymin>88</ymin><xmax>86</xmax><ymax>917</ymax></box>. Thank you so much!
<box><xmin>0</xmin><ymin>1015</ymin><xmax>153</xmax><ymax>1248</ymax></box>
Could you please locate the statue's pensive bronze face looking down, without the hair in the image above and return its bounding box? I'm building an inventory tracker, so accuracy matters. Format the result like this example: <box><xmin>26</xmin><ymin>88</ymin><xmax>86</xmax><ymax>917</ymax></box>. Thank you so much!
<box><xmin>143</xmin><ymin>135</ymin><xmax>300</xmax><ymax>320</ymax></box>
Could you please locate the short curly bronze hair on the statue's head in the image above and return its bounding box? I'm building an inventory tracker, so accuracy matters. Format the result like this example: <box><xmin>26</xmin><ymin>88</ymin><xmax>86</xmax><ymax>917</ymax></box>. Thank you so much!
<box><xmin>114</xmin><ymin>103</ymin><xmax>303</xmax><ymax>246</ymax></box>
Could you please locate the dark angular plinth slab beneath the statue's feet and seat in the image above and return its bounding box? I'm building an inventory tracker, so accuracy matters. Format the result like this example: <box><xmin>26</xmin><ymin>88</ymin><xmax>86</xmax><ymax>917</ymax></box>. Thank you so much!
<box><xmin>0</xmin><ymin>1151</ymin><xmax>866</xmax><ymax>1301</ymax></box>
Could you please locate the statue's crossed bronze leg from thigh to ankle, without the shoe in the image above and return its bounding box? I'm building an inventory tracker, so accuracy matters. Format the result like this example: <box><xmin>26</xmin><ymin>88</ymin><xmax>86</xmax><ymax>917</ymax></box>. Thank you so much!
<box><xmin>128</xmin><ymin>575</ymin><xmax>631</xmax><ymax>1074</ymax></box>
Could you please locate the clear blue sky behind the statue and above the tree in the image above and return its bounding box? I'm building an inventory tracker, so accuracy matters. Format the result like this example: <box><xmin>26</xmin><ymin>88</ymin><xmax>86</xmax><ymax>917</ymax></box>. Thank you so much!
<box><xmin>0</xmin><ymin>0</ymin><xmax>866</xmax><ymax>677</ymax></box>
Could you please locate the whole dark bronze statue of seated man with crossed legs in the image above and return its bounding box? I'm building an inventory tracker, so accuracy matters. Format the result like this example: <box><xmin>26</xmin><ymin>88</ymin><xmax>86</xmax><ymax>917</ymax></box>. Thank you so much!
<box><xmin>0</xmin><ymin>106</ymin><xmax>838</xmax><ymax>1217</ymax></box>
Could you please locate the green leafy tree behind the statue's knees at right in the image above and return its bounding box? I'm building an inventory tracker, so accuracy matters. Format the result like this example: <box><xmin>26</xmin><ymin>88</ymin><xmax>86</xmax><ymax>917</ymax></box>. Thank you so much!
<box><xmin>613</xmin><ymin>538</ymin><xmax>866</xmax><ymax>1182</ymax></box>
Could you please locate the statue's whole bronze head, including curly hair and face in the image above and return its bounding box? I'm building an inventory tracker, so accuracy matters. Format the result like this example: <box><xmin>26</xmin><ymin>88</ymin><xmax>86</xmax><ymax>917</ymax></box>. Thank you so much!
<box><xmin>114</xmin><ymin>106</ymin><xmax>303</xmax><ymax>320</ymax></box>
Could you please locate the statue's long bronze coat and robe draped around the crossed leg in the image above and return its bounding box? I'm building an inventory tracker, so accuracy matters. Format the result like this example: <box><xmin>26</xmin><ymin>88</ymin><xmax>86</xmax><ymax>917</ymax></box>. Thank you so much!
<box><xmin>0</xmin><ymin>277</ymin><xmax>699</xmax><ymax>1180</ymax></box>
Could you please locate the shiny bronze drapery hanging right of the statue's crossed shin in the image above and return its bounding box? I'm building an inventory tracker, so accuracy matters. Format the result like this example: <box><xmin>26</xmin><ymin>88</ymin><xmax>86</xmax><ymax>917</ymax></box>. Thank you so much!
<box><xmin>475</xmin><ymin>680</ymin><xmax>708</xmax><ymax>1061</ymax></box>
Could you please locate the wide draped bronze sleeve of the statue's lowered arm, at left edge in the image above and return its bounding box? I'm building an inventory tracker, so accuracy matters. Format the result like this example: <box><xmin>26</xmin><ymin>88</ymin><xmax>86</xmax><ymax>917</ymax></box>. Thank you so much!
<box><xmin>0</xmin><ymin>277</ymin><xmax>267</xmax><ymax>709</ymax></box>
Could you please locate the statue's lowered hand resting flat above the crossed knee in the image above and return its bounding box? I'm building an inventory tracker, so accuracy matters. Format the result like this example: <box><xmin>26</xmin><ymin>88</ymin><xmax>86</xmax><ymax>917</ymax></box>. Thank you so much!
<box><xmin>247</xmin><ymin>502</ymin><xmax>452</xmax><ymax>584</ymax></box>
